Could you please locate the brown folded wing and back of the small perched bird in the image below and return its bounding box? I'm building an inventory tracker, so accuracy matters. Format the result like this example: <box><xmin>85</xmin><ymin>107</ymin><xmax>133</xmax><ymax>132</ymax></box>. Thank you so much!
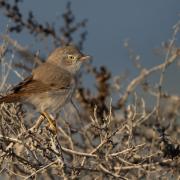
<box><xmin>12</xmin><ymin>64</ymin><xmax>72</xmax><ymax>94</ymax></box>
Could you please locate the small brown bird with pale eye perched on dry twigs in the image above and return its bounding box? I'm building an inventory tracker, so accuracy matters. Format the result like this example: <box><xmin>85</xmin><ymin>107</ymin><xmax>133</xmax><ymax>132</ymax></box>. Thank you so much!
<box><xmin>0</xmin><ymin>45</ymin><xmax>90</xmax><ymax>130</ymax></box>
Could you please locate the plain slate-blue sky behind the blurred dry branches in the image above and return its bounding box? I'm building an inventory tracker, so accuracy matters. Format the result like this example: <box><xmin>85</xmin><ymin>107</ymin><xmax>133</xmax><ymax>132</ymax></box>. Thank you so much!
<box><xmin>0</xmin><ymin>0</ymin><xmax>180</xmax><ymax>94</ymax></box>
